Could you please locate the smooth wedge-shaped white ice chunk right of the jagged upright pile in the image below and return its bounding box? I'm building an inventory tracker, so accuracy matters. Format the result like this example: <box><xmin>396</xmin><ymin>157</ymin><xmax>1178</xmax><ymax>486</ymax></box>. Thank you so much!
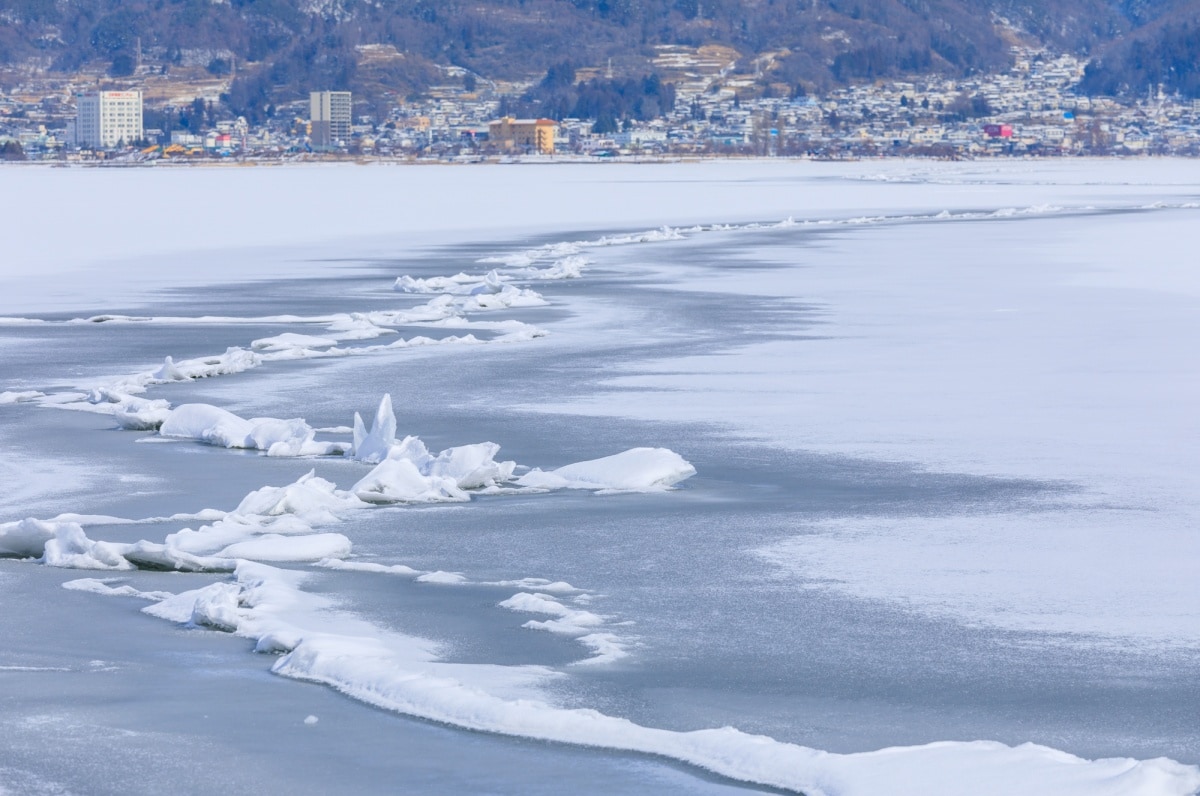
<box><xmin>516</xmin><ymin>448</ymin><xmax>696</xmax><ymax>492</ymax></box>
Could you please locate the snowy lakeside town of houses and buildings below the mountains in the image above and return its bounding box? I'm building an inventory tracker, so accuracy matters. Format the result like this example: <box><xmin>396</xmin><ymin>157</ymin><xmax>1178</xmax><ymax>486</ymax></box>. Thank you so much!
<box><xmin>0</xmin><ymin>46</ymin><xmax>1200</xmax><ymax>163</ymax></box>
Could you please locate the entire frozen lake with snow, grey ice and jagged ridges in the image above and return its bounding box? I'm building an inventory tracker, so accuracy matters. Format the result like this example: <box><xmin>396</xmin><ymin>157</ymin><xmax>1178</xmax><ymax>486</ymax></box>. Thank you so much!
<box><xmin>0</xmin><ymin>161</ymin><xmax>1200</xmax><ymax>795</ymax></box>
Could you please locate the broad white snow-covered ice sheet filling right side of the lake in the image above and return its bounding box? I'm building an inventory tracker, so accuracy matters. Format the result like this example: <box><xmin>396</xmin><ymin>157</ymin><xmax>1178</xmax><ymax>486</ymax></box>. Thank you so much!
<box><xmin>538</xmin><ymin>203</ymin><xmax>1200</xmax><ymax>646</ymax></box>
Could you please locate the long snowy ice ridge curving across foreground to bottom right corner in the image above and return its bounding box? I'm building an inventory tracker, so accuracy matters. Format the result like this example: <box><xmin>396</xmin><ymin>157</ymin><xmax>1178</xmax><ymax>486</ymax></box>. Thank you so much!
<box><xmin>110</xmin><ymin>563</ymin><xmax>1200</xmax><ymax>796</ymax></box>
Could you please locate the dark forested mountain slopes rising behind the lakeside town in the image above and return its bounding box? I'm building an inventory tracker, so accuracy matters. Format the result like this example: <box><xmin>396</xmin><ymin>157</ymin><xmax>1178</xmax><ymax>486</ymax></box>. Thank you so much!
<box><xmin>0</xmin><ymin>0</ymin><xmax>1200</xmax><ymax>115</ymax></box>
